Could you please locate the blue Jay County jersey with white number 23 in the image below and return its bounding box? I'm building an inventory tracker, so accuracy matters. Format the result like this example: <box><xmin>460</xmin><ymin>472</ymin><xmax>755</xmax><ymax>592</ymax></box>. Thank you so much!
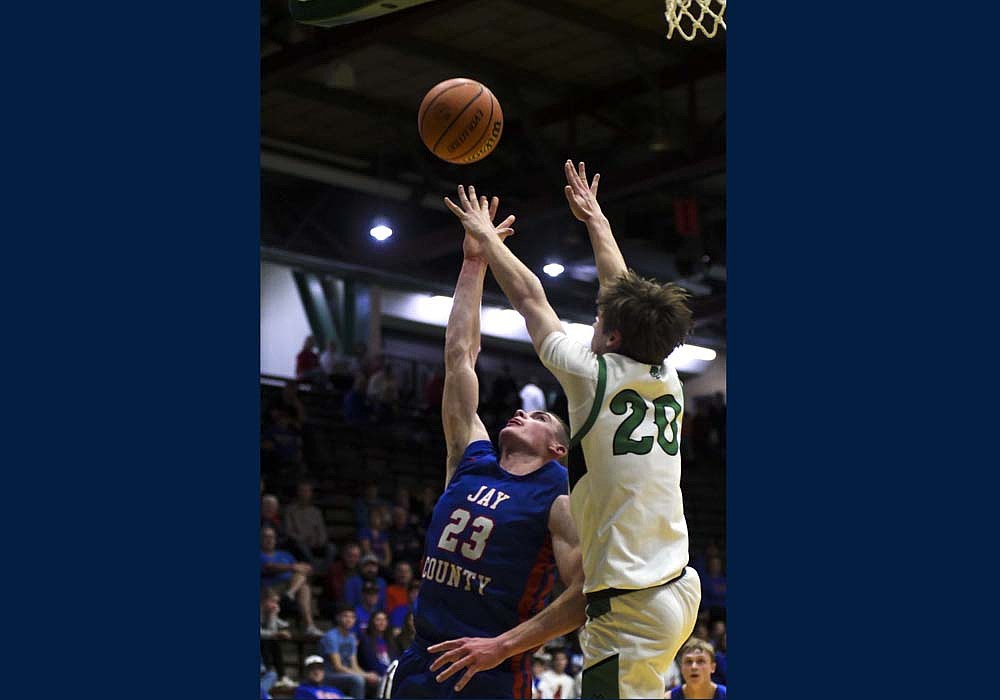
<box><xmin>414</xmin><ymin>440</ymin><xmax>569</xmax><ymax>652</ymax></box>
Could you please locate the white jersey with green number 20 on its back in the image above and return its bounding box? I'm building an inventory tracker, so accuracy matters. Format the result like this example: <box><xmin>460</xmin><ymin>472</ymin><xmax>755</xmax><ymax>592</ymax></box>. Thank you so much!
<box><xmin>539</xmin><ymin>331</ymin><xmax>688</xmax><ymax>593</ymax></box>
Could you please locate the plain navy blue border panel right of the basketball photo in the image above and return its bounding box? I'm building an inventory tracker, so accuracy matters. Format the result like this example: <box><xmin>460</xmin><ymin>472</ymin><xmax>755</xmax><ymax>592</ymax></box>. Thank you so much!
<box><xmin>727</xmin><ymin>2</ymin><xmax>997</xmax><ymax>698</ymax></box>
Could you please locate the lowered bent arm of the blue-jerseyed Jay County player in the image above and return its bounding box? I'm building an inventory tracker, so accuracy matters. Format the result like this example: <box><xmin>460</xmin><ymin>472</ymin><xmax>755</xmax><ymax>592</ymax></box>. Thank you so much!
<box><xmin>427</xmin><ymin>496</ymin><xmax>587</xmax><ymax>692</ymax></box>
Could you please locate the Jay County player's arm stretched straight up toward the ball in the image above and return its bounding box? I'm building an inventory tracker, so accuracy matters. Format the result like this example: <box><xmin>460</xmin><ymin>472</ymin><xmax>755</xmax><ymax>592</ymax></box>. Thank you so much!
<box><xmin>441</xmin><ymin>191</ymin><xmax>514</xmax><ymax>486</ymax></box>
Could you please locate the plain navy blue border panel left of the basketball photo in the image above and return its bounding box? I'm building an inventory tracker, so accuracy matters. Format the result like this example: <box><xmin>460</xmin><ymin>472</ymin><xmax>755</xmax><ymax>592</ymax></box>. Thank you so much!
<box><xmin>2</xmin><ymin>3</ymin><xmax>259</xmax><ymax>698</ymax></box>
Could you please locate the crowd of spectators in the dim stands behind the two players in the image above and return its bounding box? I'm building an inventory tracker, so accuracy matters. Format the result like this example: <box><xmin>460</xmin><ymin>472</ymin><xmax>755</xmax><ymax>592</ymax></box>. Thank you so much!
<box><xmin>260</xmin><ymin>337</ymin><xmax>726</xmax><ymax>698</ymax></box>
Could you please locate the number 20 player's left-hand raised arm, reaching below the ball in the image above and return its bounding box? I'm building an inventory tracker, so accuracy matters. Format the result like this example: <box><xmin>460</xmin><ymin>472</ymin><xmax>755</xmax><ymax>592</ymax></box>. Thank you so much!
<box><xmin>444</xmin><ymin>185</ymin><xmax>562</xmax><ymax>351</ymax></box>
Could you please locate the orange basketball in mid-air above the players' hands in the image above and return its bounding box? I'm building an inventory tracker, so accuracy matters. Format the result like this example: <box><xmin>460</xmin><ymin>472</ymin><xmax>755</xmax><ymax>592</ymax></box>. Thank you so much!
<box><xmin>417</xmin><ymin>78</ymin><xmax>503</xmax><ymax>164</ymax></box>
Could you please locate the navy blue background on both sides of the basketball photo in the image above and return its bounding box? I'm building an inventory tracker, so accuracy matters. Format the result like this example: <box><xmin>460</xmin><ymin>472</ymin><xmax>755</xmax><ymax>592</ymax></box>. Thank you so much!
<box><xmin>2</xmin><ymin>2</ymin><xmax>997</xmax><ymax>698</ymax></box>
